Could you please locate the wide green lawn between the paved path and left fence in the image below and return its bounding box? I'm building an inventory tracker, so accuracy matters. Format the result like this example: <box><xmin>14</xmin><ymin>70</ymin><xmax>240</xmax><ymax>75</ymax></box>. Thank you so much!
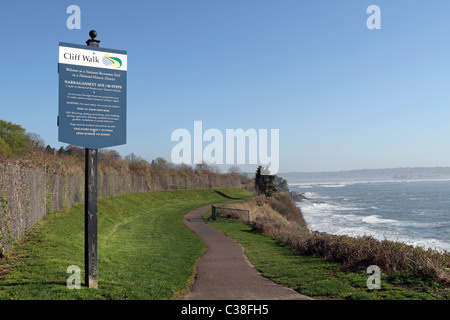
<box><xmin>0</xmin><ymin>188</ymin><xmax>252</xmax><ymax>300</ymax></box>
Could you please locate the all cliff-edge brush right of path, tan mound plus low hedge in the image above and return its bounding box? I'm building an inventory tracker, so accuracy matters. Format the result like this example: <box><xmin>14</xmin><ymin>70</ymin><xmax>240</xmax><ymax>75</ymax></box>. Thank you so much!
<box><xmin>235</xmin><ymin>193</ymin><xmax>450</xmax><ymax>286</ymax></box>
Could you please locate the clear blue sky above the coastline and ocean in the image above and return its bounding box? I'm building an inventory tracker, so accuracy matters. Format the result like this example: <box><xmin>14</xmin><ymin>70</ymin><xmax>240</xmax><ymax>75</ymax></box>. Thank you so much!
<box><xmin>0</xmin><ymin>0</ymin><xmax>450</xmax><ymax>172</ymax></box>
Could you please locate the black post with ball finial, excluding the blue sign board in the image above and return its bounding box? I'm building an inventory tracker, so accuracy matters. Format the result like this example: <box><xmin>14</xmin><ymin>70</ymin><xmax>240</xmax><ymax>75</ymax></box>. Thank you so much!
<box><xmin>84</xmin><ymin>30</ymin><xmax>100</xmax><ymax>289</ymax></box>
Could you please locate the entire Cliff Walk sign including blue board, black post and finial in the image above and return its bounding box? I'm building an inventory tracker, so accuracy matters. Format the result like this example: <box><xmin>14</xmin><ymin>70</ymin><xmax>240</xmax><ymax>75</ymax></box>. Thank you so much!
<box><xmin>58</xmin><ymin>30</ymin><xmax>127</xmax><ymax>288</ymax></box>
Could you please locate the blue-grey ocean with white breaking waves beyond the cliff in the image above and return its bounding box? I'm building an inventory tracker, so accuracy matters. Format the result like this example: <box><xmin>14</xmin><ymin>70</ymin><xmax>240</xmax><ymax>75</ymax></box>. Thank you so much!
<box><xmin>289</xmin><ymin>181</ymin><xmax>450</xmax><ymax>251</ymax></box>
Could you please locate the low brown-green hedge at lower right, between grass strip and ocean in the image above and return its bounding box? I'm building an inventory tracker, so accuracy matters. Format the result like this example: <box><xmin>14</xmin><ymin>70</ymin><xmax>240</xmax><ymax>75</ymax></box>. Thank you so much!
<box><xmin>278</xmin><ymin>233</ymin><xmax>450</xmax><ymax>285</ymax></box>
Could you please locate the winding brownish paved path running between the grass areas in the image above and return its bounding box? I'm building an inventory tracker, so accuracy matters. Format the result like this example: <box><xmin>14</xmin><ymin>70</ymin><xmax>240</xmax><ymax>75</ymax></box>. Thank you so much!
<box><xmin>183</xmin><ymin>206</ymin><xmax>312</xmax><ymax>300</ymax></box>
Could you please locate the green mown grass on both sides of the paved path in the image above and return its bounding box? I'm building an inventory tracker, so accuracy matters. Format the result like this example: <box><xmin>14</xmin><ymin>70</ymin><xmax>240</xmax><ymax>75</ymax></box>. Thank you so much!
<box><xmin>0</xmin><ymin>188</ymin><xmax>450</xmax><ymax>300</ymax></box>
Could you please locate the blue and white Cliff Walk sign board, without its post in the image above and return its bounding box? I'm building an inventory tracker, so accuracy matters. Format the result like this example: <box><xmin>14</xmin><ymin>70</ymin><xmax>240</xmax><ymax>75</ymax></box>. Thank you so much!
<box><xmin>58</xmin><ymin>42</ymin><xmax>128</xmax><ymax>149</ymax></box>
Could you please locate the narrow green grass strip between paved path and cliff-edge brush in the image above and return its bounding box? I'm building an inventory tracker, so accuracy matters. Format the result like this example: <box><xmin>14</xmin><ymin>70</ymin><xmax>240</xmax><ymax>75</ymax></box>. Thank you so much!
<box><xmin>210</xmin><ymin>220</ymin><xmax>450</xmax><ymax>300</ymax></box>
